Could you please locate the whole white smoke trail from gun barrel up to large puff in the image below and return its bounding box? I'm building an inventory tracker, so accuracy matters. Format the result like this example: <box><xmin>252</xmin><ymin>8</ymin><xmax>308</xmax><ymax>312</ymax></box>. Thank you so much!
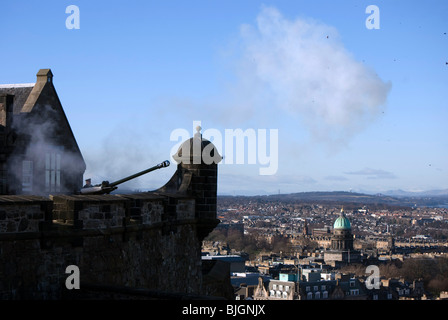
<box><xmin>80</xmin><ymin>7</ymin><xmax>391</xmax><ymax>192</ymax></box>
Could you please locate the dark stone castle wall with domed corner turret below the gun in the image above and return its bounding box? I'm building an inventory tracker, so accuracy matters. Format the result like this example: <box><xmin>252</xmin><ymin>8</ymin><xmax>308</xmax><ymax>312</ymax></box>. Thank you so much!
<box><xmin>0</xmin><ymin>137</ymin><xmax>219</xmax><ymax>300</ymax></box>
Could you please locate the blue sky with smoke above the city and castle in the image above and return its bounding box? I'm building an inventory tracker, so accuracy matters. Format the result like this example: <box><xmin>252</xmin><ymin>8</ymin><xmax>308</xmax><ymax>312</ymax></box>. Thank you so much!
<box><xmin>0</xmin><ymin>0</ymin><xmax>448</xmax><ymax>194</ymax></box>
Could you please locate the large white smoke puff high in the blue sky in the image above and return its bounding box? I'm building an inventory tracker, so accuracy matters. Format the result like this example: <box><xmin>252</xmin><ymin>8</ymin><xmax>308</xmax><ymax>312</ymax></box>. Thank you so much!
<box><xmin>222</xmin><ymin>7</ymin><xmax>391</xmax><ymax>143</ymax></box>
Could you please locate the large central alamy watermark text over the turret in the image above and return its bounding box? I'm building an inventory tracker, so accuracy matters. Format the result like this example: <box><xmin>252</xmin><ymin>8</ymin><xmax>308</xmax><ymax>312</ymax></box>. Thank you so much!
<box><xmin>170</xmin><ymin>121</ymin><xmax>278</xmax><ymax>175</ymax></box>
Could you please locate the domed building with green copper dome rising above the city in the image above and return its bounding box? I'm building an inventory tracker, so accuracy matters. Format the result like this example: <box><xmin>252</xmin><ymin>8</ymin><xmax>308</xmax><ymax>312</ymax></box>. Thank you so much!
<box><xmin>324</xmin><ymin>208</ymin><xmax>361</xmax><ymax>266</ymax></box>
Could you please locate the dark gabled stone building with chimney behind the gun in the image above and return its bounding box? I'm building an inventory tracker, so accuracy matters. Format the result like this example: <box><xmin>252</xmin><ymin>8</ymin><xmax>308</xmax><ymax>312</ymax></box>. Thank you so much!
<box><xmin>0</xmin><ymin>69</ymin><xmax>86</xmax><ymax>195</ymax></box>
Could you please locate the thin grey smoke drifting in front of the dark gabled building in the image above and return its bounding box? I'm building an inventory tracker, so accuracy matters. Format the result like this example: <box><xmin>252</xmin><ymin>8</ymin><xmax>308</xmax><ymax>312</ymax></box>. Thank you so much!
<box><xmin>7</xmin><ymin>105</ymin><xmax>83</xmax><ymax>195</ymax></box>
